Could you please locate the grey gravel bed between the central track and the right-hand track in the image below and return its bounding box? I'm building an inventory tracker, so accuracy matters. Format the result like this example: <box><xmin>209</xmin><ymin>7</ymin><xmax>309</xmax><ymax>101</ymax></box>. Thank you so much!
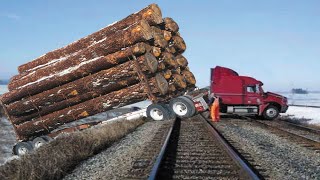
<box><xmin>215</xmin><ymin>120</ymin><xmax>320</xmax><ymax>179</ymax></box>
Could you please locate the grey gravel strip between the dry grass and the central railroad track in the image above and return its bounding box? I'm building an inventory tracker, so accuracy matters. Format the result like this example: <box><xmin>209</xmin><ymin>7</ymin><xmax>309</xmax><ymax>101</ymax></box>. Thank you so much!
<box><xmin>64</xmin><ymin>121</ymin><xmax>173</xmax><ymax>180</ymax></box>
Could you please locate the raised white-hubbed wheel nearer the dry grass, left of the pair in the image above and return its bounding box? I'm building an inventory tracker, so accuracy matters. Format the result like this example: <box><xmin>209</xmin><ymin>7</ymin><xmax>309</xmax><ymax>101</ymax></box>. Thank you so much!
<box><xmin>147</xmin><ymin>104</ymin><xmax>171</xmax><ymax>121</ymax></box>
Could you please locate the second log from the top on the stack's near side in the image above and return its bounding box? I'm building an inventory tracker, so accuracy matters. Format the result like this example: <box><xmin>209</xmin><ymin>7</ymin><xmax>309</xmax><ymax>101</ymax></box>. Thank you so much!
<box><xmin>8</xmin><ymin>21</ymin><xmax>152</xmax><ymax>90</ymax></box>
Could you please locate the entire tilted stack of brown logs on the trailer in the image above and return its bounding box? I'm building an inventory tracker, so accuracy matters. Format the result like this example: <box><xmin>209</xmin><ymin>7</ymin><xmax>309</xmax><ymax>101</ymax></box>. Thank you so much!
<box><xmin>0</xmin><ymin>4</ymin><xmax>196</xmax><ymax>140</ymax></box>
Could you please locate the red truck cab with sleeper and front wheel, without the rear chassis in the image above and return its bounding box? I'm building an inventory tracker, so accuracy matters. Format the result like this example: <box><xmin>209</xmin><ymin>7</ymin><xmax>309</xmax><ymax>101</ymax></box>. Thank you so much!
<box><xmin>210</xmin><ymin>66</ymin><xmax>288</xmax><ymax>120</ymax></box>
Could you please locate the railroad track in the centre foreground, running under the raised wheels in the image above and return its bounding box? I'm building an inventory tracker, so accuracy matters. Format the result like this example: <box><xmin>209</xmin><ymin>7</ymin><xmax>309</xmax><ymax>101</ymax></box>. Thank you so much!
<box><xmin>149</xmin><ymin>115</ymin><xmax>260</xmax><ymax>179</ymax></box>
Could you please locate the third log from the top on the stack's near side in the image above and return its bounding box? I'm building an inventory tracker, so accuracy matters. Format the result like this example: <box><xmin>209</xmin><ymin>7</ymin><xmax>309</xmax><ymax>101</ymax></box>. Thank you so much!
<box><xmin>1</xmin><ymin>43</ymin><xmax>156</xmax><ymax>104</ymax></box>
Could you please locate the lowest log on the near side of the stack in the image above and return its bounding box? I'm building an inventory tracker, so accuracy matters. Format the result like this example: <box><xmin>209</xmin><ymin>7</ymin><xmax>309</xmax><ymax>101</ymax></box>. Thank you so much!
<box><xmin>16</xmin><ymin>75</ymin><xmax>166</xmax><ymax>140</ymax></box>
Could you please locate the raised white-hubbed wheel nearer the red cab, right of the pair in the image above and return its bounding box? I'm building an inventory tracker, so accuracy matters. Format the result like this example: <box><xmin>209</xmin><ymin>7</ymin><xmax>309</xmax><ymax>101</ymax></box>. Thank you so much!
<box><xmin>169</xmin><ymin>96</ymin><xmax>196</xmax><ymax>118</ymax></box>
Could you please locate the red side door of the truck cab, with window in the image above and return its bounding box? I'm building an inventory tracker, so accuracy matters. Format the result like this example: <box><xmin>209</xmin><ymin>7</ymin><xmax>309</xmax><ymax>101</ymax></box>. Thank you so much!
<box><xmin>243</xmin><ymin>85</ymin><xmax>262</xmax><ymax>106</ymax></box>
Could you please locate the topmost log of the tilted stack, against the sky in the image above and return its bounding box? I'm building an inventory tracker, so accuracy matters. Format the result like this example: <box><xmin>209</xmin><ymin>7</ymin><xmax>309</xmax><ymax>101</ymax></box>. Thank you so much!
<box><xmin>18</xmin><ymin>4</ymin><xmax>163</xmax><ymax>73</ymax></box>
